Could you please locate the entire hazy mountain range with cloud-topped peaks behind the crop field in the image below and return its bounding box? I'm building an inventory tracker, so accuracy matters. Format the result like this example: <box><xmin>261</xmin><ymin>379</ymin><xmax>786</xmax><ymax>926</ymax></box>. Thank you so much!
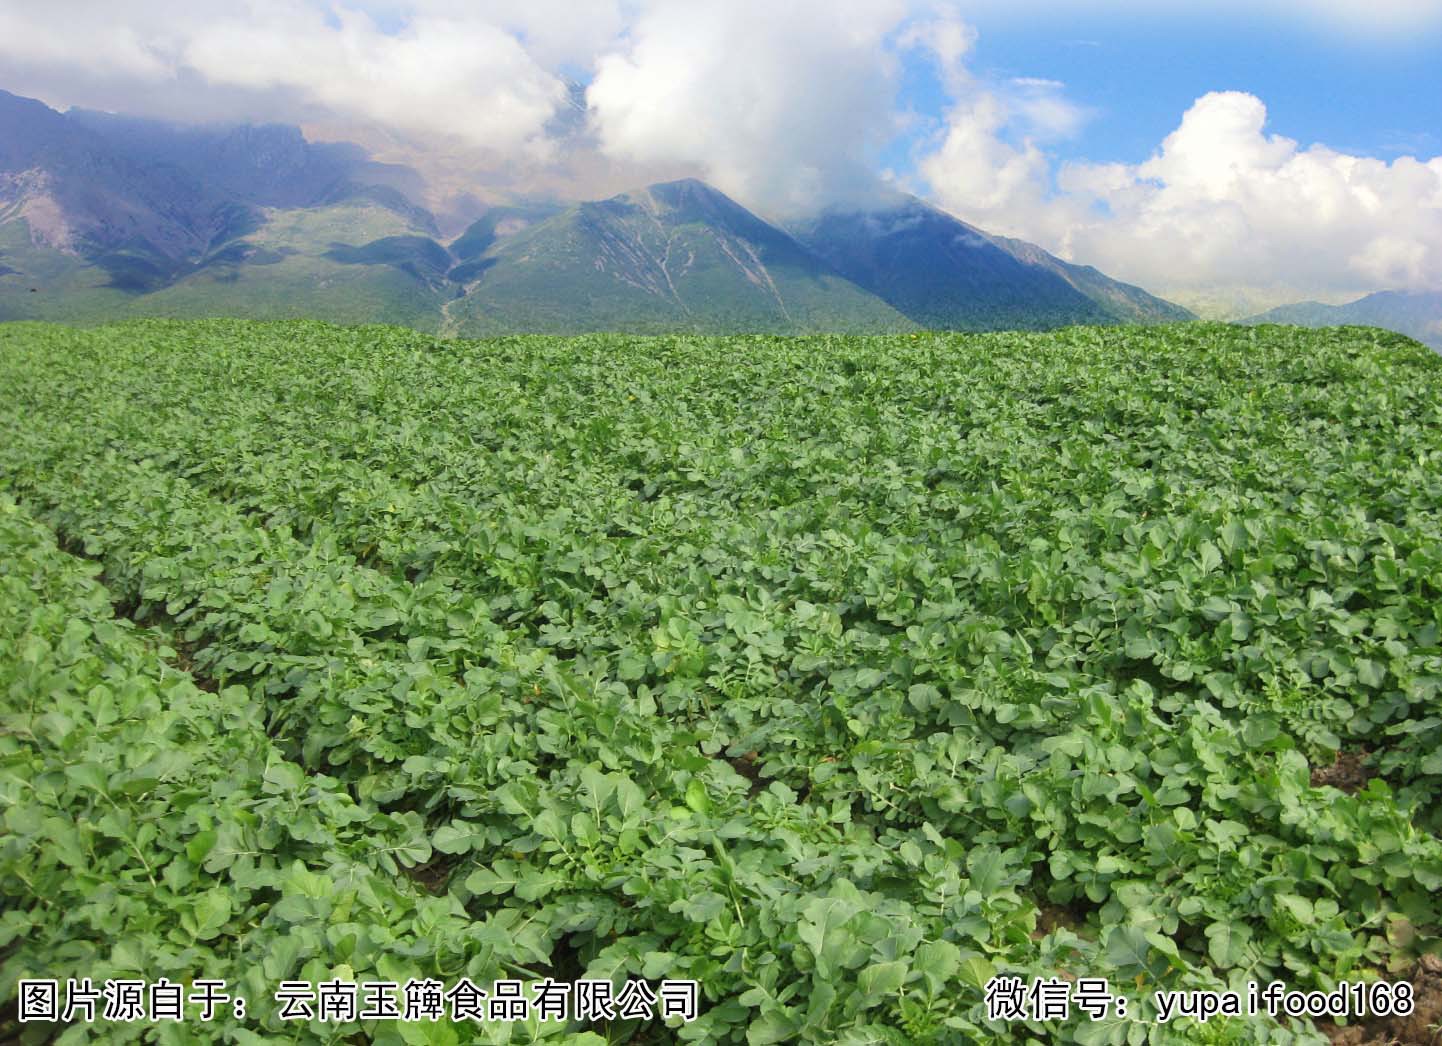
<box><xmin>0</xmin><ymin>92</ymin><xmax>1191</xmax><ymax>335</ymax></box>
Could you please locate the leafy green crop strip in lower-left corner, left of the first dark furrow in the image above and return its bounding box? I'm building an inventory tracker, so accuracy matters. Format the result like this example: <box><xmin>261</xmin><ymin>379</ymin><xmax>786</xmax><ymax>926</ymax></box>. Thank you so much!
<box><xmin>0</xmin><ymin>495</ymin><xmax>591</xmax><ymax>1043</ymax></box>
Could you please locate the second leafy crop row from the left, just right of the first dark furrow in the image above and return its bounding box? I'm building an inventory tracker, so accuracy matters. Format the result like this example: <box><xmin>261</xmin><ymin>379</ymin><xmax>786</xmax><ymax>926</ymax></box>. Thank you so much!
<box><xmin>6</xmin><ymin>330</ymin><xmax>1067</xmax><ymax>1037</ymax></box>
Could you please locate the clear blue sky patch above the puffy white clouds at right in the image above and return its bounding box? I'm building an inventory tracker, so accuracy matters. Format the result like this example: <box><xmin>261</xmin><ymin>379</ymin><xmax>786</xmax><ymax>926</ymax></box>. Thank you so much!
<box><xmin>884</xmin><ymin>3</ymin><xmax>1442</xmax><ymax>169</ymax></box>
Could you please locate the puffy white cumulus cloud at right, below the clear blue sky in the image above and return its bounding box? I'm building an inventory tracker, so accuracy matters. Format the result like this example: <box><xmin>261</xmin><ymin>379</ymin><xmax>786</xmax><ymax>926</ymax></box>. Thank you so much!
<box><xmin>921</xmin><ymin>92</ymin><xmax>1442</xmax><ymax>309</ymax></box>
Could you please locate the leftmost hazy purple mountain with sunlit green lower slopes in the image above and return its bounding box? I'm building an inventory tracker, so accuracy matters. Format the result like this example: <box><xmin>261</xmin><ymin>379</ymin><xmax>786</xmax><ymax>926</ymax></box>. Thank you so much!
<box><xmin>0</xmin><ymin>92</ymin><xmax>443</xmax><ymax>326</ymax></box>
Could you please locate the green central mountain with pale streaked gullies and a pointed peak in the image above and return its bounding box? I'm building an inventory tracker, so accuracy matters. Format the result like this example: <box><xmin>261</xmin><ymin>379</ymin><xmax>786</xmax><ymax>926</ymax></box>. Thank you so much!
<box><xmin>448</xmin><ymin>179</ymin><xmax>913</xmax><ymax>333</ymax></box>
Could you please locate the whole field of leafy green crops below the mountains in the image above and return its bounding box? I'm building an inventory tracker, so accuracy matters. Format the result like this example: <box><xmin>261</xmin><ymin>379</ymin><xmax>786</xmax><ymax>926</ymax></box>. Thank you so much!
<box><xmin>0</xmin><ymin>320</ymin><xmax>1442</xmax><ymax>1046</ymax></box>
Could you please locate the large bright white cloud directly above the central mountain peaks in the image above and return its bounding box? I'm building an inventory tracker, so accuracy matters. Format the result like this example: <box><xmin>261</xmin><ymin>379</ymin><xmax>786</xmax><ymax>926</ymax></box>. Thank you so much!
<box><xmin>587</xmin><ymin>0</ymin><xmax>907</xmax><ymax>214</ymax></box>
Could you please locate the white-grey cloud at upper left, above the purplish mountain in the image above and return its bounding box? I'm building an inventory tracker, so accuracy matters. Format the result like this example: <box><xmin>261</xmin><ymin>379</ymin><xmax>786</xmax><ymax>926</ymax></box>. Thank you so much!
<box><xmin>0</xmin><ymin>0</ymin><xmax>573</xmax><ymax>153</ymax></box>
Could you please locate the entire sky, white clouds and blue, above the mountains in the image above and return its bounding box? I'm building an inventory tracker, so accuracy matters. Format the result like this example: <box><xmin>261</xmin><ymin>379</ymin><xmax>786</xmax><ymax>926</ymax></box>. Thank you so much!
<box><xmin>0</xmin><ymin>0</ymin><xmax>1442</xmax><ymax>316</ymax></box>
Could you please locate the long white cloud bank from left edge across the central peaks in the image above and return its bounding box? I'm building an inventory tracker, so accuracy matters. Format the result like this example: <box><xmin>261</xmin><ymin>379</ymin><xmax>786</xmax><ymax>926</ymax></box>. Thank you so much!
<box><xmin>0</xmin><ymin>0</ymin><xmax>934</xmax><ymax>215</ymax></box>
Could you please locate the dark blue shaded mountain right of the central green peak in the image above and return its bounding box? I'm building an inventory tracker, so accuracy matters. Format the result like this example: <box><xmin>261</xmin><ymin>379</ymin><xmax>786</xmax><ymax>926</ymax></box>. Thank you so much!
<box><xmin>792</xmin><ymin>196</ymin><xmax>1194</xmax><ymax>330</ymax></box>
